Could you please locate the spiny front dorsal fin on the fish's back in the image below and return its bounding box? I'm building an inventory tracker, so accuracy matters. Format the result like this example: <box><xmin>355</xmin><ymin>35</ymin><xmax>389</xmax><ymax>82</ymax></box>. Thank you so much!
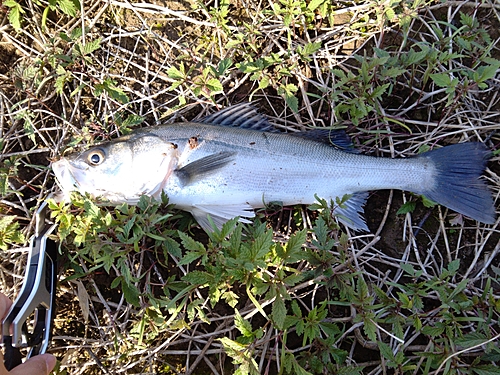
<box><xmin>194</xmin><ymin>103</ymin><xmax>276</xmax><ymax>132</ymax></box>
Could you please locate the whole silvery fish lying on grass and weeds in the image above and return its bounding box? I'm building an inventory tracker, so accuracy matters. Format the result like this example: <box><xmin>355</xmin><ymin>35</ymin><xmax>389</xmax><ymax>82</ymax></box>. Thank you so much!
<box><xmin>52</xmin><ymin>103</ymin><xmax>496</xmax><ymax>232</ymax></box>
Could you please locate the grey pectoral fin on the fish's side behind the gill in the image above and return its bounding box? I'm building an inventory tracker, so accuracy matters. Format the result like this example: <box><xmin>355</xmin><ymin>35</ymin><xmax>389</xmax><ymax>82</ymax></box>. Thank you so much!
<box><xmin>174</xmin><ymin>151</ymin><xmax>236</xmax><ymax>185</ymax></box>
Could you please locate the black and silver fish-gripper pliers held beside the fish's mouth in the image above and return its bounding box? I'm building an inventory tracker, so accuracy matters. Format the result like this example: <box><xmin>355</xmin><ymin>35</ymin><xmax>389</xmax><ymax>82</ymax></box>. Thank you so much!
<box><xmin>2</xmin><ymin>200</ymin><xmax>57</xmax><ymax>370</ymax></box>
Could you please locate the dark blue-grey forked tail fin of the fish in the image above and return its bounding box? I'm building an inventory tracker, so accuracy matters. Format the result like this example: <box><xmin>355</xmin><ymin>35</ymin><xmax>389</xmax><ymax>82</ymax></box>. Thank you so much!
<box><xmin>419</xmin><ymin>142</ymin><xmax>496</xmax><ymax>224</ymax></box>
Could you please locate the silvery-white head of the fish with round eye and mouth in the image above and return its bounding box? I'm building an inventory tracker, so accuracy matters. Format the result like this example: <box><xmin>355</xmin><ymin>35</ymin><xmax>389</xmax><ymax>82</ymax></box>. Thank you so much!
<box><xmin>52</xmin><ymin>134</ymin><xmax>178</xmax><ymax>204</ymax></box>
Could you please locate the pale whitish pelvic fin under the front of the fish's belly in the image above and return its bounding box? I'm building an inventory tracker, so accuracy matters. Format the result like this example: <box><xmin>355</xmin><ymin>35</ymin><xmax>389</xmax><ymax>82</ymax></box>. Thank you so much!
<box><xmin>189</xmin><ymin>204</ymin><xmax>255</xmax><ymax>232</ymax></box>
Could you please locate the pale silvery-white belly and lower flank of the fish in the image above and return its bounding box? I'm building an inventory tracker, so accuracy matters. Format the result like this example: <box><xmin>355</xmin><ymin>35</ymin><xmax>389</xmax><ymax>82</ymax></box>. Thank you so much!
<box><xmin>165</xmin><ymin>151</ymin><xmax>434</xmax><ymax>208</ymax></box>
